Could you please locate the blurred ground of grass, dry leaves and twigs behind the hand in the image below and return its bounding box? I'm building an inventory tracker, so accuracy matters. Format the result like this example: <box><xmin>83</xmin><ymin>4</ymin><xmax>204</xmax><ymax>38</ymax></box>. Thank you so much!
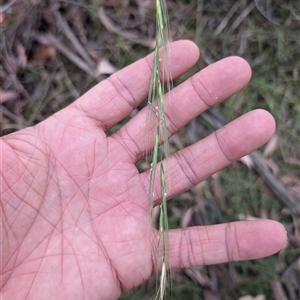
<box><xmin>0</xmin><ymin>0</ymin><xmax>300</xmax><ymax>300</ymax></box>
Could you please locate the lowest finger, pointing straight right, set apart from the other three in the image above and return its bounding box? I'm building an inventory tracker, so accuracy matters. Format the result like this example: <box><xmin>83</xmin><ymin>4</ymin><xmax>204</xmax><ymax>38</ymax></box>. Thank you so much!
<box><xmin>163</xmin><ymin>220</ymin><xmax>286</xmax><ymax>269</ymax></box>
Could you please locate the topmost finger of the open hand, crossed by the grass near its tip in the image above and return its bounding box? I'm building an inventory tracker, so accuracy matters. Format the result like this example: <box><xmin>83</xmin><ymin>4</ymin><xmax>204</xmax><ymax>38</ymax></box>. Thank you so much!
<box><xmin>72</xmin><ymin>40</ymin><xmax>199</xmax><ymax>130</ymax></box>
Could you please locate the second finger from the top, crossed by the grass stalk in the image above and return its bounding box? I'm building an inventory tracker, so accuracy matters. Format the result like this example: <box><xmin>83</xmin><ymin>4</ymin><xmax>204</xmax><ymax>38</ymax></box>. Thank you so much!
<box><xmin>111</xmin><ymin>57</ymin><xmax>251</xmax><ymax>162</ymax></box>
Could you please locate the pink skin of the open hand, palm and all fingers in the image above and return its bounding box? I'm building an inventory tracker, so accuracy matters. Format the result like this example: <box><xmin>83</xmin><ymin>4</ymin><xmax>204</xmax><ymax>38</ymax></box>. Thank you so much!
<box><xmin>0</xmin><ymin>41</ymin><xmax>286</xmax><ymax>300</ymax></box>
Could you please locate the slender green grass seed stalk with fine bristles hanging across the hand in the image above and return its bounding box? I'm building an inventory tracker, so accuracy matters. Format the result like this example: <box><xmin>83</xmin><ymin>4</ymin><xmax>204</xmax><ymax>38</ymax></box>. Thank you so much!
<box><xmin>148</xmin><ymin>0</ymin><xmax>172</xmax><ymax>300</ymax></box>
